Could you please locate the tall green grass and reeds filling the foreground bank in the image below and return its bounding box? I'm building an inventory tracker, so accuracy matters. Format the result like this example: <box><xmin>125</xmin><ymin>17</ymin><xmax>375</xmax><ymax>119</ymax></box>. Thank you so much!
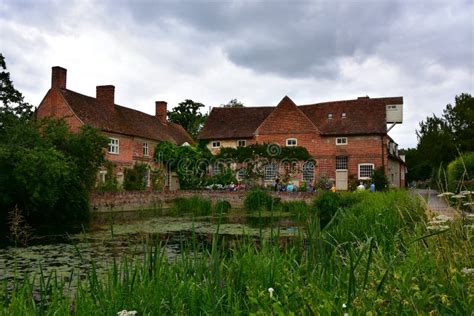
<box><xmin>0</xmin><ymin>191</ymin><xmax>474</xmax><ymax>315</ymax></box>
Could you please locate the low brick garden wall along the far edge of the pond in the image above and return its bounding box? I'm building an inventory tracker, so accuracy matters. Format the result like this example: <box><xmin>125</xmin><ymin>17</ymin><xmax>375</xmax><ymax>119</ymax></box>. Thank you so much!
<box><xmin>90</xmin><ymin>191</ymin><xmax>314</xmax><ymax>212</ymax></box>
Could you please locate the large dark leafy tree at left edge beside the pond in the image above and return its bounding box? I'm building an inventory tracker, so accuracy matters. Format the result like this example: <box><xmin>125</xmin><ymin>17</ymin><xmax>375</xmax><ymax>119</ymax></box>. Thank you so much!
<box><xmin>0</xmin><ymin>55</ymin><xmax>107</xmax><ymax>236</ymax></box>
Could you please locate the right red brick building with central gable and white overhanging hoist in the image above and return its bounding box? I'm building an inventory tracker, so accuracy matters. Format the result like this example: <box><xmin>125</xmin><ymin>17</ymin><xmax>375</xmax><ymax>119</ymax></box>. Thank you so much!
<box><xmin>198</xmin><ymin>97</ymin><xmax>406</xmax><ymax>190</ymax></box>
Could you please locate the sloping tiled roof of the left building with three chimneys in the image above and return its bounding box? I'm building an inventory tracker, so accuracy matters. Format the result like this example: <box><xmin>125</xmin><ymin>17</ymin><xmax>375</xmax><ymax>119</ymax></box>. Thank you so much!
<box><xmin>60</xmin><ymin>89</ymin><xmax>193</xmax><ymax>145</ymax></box>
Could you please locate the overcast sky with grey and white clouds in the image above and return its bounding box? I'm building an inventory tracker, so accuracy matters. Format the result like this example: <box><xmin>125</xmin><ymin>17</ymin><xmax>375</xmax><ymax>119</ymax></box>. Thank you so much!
<box><xmin>0</xmin><ymin>0</ymin><xmax>474</xmax><ymax>148</ymax></box>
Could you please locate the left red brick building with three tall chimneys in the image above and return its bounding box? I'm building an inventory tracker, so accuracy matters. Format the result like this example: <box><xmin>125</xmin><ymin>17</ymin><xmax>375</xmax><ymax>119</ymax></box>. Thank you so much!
<box><xmin>36</xmin><ymin>67</ymin><xmax>192</xmax><ymax>183</ymax></box>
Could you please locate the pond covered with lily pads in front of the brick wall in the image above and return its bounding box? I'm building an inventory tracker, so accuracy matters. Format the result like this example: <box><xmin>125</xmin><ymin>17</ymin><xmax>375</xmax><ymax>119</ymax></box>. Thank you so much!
<box><xmin>0</xmin><ymin>210</ymin><xmax>297</xmax><ymax>287</ymax></box>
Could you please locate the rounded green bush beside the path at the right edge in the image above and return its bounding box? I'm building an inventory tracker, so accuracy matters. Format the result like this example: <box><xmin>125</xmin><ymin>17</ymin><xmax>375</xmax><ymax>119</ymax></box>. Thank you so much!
<box><xmin>448</xmin><ymin>152</ymin><xmax>474</xmax><ymax>192</ymax></box>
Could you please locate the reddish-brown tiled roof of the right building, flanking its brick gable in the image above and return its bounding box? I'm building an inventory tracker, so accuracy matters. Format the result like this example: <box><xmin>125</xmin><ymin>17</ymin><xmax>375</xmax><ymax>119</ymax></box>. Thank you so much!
<box><xmin>198</xmin><ymin>97</ymin><xmax>403</xmax><ymax>139</ymax></box>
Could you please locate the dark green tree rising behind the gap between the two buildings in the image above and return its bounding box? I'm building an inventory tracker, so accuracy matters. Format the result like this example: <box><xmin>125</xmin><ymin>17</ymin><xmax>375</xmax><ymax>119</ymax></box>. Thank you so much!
<box><xmin>168</xmin><ymin>99</ymin><xmax>207</xmax><ymax>139</ymax></box>
